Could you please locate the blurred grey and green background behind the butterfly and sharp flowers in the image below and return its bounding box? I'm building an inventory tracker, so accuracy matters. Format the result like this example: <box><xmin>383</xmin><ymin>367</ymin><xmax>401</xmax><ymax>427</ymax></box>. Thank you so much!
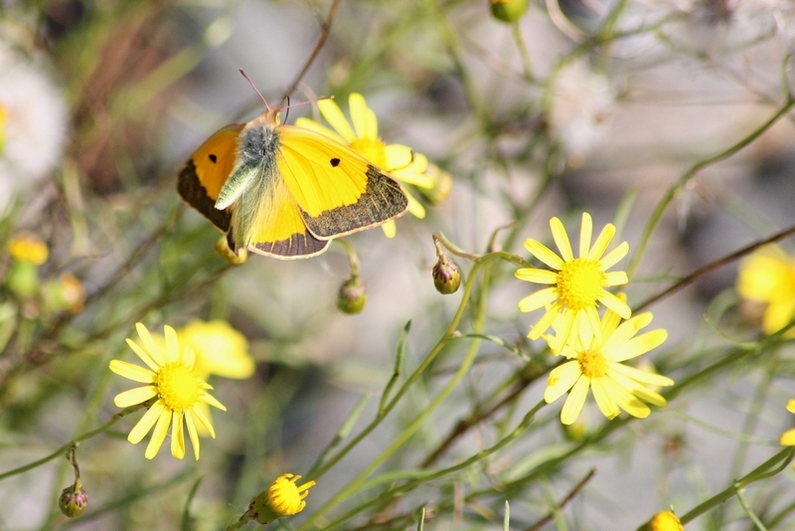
<box><xmin>0</xmin><ymin>0</ymin><xmax>795</xmax><ymax>530</ymax></box>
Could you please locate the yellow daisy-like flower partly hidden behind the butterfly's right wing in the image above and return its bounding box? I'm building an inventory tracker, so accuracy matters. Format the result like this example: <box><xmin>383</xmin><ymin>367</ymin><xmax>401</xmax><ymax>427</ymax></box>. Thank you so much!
<box><xmin>295</xmin><ymin>92</ymin><xmax>452</xmax><ymax>238</ymax></box>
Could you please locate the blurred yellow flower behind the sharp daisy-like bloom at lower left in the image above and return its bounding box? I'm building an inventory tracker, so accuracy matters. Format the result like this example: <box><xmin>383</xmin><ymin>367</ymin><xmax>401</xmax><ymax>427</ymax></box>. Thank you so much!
<box><xmin>177</xmin><ymin>319</ymin><xmax>254</xmax><ymax>379</ymax></box>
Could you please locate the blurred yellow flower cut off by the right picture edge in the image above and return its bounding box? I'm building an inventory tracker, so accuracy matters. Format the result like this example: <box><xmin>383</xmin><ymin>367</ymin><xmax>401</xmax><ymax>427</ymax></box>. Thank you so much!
<box><xmin>737</xmin><ymin>245</ymin><xmax>795</xmax><ymax>337</ymax></box>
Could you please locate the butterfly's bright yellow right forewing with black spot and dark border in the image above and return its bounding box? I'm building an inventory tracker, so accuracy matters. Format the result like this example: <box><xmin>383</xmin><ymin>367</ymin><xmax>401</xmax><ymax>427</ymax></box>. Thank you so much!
<box><xmin>277</xmin><ymin>125</ymin><xmax>408</xmax><ymax>240</ymax></box>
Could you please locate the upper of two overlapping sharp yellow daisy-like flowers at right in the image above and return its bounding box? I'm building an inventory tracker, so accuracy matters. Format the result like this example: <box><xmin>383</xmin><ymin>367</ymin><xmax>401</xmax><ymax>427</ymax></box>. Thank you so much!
<box><xmin>516</xmin><ymin>212</ymin><xmax>632</xmax><ymax>350</ymax></box>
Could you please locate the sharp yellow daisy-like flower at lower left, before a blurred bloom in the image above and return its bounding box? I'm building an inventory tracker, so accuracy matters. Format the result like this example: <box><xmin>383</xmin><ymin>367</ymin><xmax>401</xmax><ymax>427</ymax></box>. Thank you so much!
<box><xmin>110</xmin><ymin>323</ymin><xmax>226</xmax><ymax>460</ymax></box>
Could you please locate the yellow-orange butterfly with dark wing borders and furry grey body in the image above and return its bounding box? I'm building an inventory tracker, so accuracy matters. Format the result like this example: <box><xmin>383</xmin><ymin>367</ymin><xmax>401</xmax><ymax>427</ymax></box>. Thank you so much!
<box><xmin>177</xmin><ymin>98</ymin><xmax>408</xmax><ymax>259</ymax></box>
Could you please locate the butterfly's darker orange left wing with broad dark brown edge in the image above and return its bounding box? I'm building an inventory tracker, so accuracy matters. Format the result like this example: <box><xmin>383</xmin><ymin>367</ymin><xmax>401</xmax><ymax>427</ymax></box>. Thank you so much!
<box><xmin>177</xmin><ymin>124</ymin><xmax>245</xmax><ymax>232</ymax></box>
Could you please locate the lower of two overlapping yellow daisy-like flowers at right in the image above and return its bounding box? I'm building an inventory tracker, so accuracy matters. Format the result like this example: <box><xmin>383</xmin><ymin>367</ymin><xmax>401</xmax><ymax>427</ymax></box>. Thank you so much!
<box><xmin>544</xmin><ymin>300</ymin><xmax>674</xmax><ymax>425</ymax></box>
